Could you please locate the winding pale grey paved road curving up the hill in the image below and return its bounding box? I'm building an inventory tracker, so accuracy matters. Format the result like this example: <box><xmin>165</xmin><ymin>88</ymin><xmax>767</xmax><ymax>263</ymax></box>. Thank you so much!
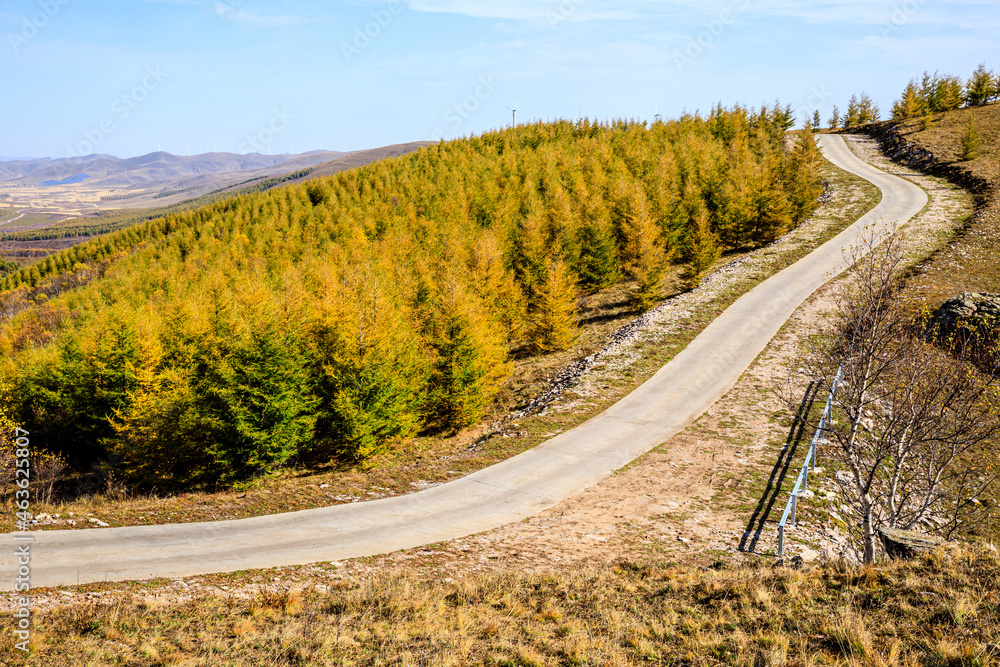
<box><xmin>0</xmin><ymin>135</ymin><xmax>927</xmax><ymax>590</ymax></box>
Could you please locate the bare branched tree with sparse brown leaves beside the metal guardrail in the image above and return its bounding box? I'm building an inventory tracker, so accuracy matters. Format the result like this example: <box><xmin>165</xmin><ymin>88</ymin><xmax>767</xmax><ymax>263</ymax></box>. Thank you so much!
<box><xmin>810</xmin><ymin>235</ymin><xmax>1000</xmax><ymax>563</ymax></box>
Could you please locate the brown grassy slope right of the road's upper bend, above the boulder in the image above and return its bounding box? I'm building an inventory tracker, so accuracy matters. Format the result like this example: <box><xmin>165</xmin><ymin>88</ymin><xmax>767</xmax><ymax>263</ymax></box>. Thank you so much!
<box><xmin>865</xmin><ymin>104</ymin><xmax>1000</xmax><ymax>310</ymax></box>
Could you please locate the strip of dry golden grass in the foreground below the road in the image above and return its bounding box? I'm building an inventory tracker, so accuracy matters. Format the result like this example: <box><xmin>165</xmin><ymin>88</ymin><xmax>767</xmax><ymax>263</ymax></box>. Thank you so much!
<box><xmin>9</xmin><ymin>550</ymin><xmax>1000</xmax><ymax>667</ymax></box>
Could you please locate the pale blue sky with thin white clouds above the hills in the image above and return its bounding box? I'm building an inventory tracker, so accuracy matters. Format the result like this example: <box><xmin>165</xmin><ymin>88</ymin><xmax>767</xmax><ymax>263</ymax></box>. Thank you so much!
<box><xmin>0</xmin><ymin>0</ymin><xmax>1000</xmax><ymax>157</ymax></box>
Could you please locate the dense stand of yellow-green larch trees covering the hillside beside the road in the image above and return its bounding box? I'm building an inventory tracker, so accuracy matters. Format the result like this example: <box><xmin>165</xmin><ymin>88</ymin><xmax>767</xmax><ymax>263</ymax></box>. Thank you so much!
<box><xmin>0</xmin><ymin>108</ymin><xmax>819</xmax><ymax>488</ymax></box>
